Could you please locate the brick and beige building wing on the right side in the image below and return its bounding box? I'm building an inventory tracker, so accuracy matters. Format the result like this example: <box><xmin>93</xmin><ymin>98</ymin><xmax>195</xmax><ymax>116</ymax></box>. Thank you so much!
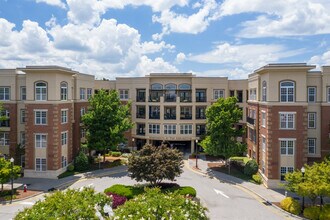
<box><xmin>247</xmin><ymin>63</ymin><xmax>330</xmax><ymax>188</ymax></box>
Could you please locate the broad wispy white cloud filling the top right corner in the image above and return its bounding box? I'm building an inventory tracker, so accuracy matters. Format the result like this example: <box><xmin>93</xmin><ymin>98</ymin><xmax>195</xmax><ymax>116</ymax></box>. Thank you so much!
<box><xmin>215</xmin><ymin>0</ymin><xmax>330</xmax><ymax>38</ymax></box>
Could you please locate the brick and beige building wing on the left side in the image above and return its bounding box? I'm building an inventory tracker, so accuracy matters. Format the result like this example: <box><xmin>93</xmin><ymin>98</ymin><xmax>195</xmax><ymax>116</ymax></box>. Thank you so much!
<box><xmin>0</xmin><ymin>66</ymin><xmax>94</xmax><ymax>178</ymax></box>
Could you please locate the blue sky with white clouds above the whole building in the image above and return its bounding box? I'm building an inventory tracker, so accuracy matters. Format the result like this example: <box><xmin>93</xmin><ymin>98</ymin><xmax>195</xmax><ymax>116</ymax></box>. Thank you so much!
<box><xmin>0</xmin><ymin>0</ymin><xmax>330</xmax><ymax>79</ymax></box>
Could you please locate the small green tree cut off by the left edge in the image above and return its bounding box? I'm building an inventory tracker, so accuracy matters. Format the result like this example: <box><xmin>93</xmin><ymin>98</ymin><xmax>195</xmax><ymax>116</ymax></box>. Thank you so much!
<box><xmin>0</xmin><ymin>158</ymin><xmax>21</xmax><ymax>191</ymax></box>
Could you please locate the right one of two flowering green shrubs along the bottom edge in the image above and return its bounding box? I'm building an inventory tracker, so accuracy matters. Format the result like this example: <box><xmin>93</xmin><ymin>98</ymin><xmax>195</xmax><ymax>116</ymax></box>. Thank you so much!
<box><xmin>114</xmin><ymin>188</ymin><xmax>208</xmax><ymax>220</ymax></box>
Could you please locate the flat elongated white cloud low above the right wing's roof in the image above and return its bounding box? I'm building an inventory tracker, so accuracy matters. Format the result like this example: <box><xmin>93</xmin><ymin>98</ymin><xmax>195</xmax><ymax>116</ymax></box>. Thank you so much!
<box><xmin>187</xmin><ymin>43</ymin><xmax>302</xmax><ymax>71</ymax></box>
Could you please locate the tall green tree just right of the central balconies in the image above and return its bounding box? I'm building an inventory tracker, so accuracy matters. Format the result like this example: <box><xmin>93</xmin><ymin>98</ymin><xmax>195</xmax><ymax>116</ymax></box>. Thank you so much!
<box><xmin>201</xmin><ymin>97</ymin><xmax>246</xmax><ymax>158</ymax></box>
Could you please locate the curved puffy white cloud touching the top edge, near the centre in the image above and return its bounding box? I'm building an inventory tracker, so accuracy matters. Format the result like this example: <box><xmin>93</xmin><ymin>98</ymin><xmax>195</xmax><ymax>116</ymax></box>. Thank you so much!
<box><xmin>152</xmin><ymin>0</ymin><xmax>219</xmax><ymax>40</ymax></box>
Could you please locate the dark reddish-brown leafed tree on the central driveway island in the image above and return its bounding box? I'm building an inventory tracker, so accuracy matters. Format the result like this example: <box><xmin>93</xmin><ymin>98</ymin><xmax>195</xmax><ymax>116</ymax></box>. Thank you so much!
<box><xmin>128</xmin><ymin>145</ymin><xmax>183</xmax><ymax>185</ymax></box>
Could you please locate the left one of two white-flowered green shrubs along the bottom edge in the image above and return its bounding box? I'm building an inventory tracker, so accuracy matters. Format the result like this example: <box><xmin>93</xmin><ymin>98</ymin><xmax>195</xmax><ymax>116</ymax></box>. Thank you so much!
<box><xmin>15</xmin><ymin>187</ymin><xmax>112</xmax><ymax>220</ymax></box>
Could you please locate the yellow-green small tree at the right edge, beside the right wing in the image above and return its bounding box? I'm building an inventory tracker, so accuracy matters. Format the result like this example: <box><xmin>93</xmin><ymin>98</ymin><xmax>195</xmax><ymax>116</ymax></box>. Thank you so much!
<box><xmin>285</xmin><ymin>159</ymin><xmax>330</xmax><ymax>205</ymax></box>
